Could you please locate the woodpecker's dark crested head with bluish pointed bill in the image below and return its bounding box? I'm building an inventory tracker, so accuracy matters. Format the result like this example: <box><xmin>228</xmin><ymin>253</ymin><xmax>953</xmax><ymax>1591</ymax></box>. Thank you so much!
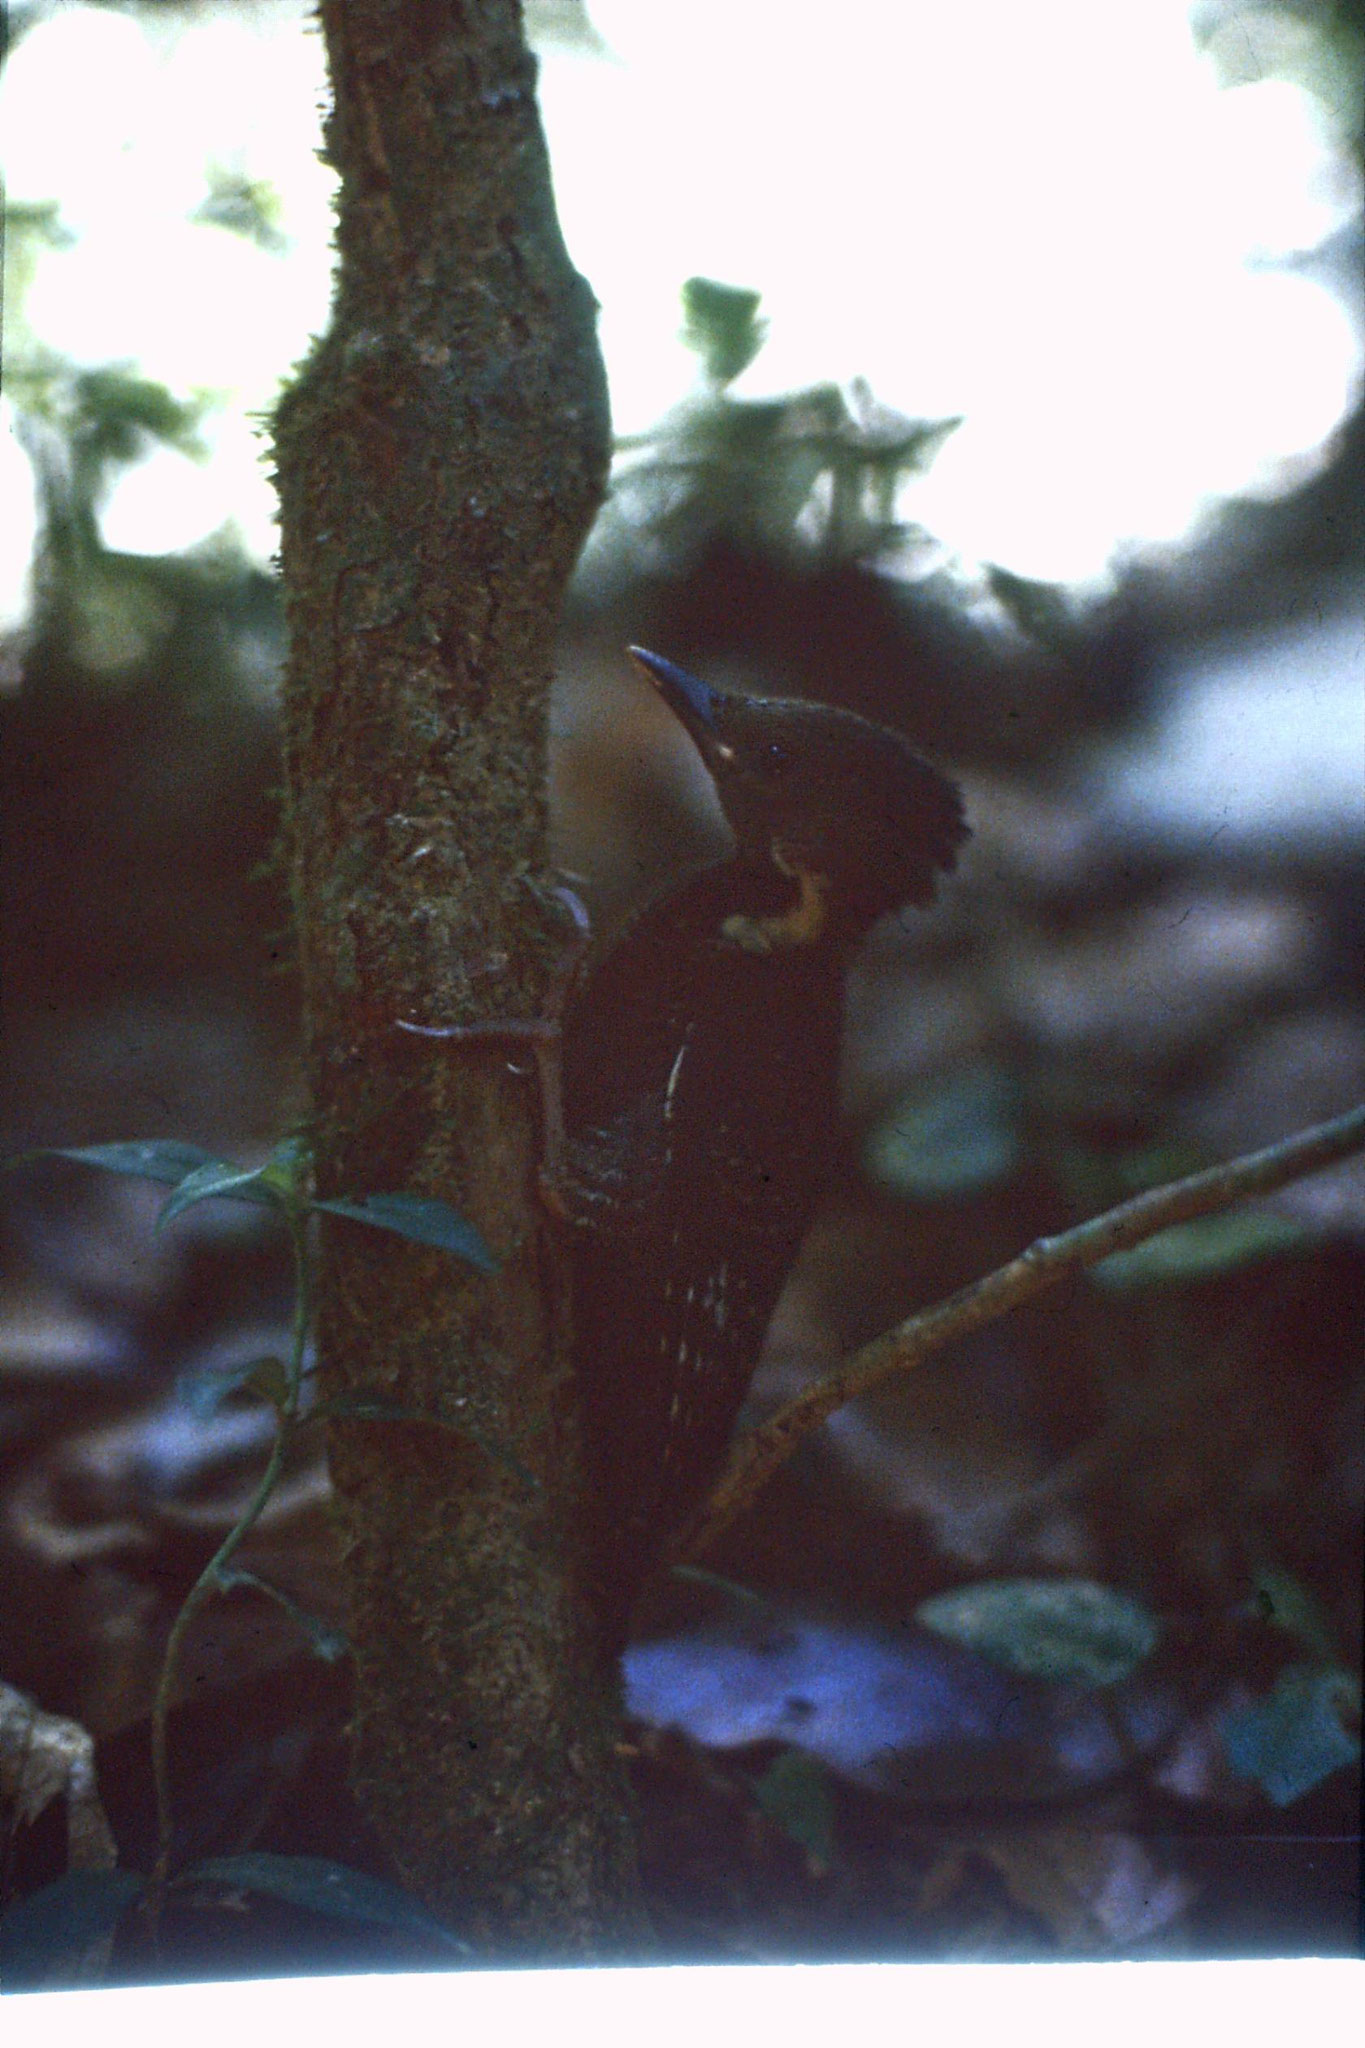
<box><xmin>630</xmin><ymin>647</ymin><xmax>968</xmax><ymax>926</ymax></box>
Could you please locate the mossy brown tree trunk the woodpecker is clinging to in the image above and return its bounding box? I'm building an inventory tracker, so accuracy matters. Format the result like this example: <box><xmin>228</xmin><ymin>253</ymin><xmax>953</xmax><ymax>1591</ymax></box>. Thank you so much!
<box><xmin>276</xmin><ymin>0</ymin><xmax>639</xmax><ymax>1958</ymax></box>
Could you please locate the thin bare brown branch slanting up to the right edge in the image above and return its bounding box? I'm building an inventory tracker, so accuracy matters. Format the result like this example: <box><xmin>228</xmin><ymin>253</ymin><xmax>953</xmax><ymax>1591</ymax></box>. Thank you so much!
<box><xmin>675</xmin><ymin>1104</ymin><xmax>1365</xmax><ymax>1561</ymax></box>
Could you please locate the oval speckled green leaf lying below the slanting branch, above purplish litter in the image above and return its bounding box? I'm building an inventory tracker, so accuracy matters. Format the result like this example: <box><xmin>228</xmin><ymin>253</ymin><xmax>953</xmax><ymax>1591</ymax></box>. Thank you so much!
<box><xmin>917</xmin><ymin>1579</ymin><xmax>1158</xmax><ymax>1686</ymax></box>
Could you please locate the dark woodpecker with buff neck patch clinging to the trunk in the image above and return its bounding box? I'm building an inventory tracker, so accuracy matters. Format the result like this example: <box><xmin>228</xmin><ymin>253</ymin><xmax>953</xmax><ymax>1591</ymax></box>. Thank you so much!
<box><xmin>559</xmin><ymin>647</ymin><xmax>966</xmax><ymax>1649</ymax></box>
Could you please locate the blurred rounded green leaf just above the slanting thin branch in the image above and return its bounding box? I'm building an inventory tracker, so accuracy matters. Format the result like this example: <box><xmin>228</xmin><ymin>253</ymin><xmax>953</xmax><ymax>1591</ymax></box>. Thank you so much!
<box><xmin>866</xmin><ymin>1065</ymin><xmax>1019</xmax><ymax>1202</ymax></box>
